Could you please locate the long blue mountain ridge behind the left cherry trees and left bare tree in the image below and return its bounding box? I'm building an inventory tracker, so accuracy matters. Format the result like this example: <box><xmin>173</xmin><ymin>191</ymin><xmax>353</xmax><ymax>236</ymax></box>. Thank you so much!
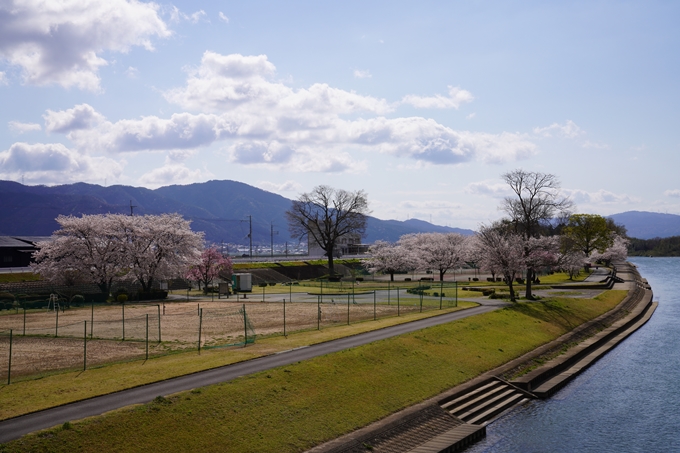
<box><xmin>0</xmin><ymin>180</ymin><xmax>474</xmax><ymax>245</ymax></box>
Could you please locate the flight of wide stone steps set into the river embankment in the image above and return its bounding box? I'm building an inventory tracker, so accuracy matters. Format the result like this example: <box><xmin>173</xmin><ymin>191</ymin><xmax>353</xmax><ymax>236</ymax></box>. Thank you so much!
<box><xmin>441</xmin><ymin>378</ymin><xmax>532</xmax><ymax>425</ymax></box>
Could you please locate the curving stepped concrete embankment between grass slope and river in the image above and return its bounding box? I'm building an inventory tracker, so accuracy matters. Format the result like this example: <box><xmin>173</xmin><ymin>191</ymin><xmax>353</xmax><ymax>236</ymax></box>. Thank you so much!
<box><xmin>310</xmin><ymin>263</ymin><xmax>657</xmax><ymax>453</ymax></box>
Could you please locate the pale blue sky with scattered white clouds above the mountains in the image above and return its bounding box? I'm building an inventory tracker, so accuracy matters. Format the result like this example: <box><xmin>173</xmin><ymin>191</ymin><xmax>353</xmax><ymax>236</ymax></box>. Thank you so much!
<box><xmin>0</xmin><ymin>0</ymin><xmax>680</xmax><ymax>229</ymax></box>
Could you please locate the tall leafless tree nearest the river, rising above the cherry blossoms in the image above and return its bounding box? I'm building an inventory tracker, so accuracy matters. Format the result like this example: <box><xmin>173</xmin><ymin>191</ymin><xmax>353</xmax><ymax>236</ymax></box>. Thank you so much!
<box><xmin>501</xmin><ymin>169</ymin><xmax>573</xmax><ymax>299</ymax></box>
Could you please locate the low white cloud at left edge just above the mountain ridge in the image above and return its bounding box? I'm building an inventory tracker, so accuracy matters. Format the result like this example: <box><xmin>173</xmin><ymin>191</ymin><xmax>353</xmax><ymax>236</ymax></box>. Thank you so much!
<box><xmin>0</xmin><ymin>142</ymin><xmax>123</xmax><ymax>182</ymax></box>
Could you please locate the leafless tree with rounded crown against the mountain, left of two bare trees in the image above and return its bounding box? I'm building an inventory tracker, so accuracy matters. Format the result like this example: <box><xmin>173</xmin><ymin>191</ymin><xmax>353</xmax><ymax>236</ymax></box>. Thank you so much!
<box><xmin>286</xmin><ymin>186</ymin><xmax>369</xmax><ymax>276</ymax></box>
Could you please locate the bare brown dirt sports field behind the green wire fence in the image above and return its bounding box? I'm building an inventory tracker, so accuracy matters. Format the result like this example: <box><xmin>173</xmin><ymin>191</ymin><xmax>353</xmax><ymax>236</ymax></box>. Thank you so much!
<box><xmin>0</xmin><ymin>293</ymin><xmax>451</xmax><ymax>381</ymax></box>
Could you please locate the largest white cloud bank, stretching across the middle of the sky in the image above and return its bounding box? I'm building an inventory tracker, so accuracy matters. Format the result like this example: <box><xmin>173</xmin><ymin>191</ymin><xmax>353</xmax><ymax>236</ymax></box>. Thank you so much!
<box><xmin>45</xmin><ymin>52</ymin><xmax>537</xmax><ymax>172</ymax></box>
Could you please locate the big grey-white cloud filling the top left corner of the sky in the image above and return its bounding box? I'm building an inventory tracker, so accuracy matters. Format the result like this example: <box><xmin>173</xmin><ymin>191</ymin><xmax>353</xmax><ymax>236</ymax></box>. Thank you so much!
<box><xmin>0</xmin><ymin>0</ymin><xmax>170</xmax><ymax>91</ymax></box>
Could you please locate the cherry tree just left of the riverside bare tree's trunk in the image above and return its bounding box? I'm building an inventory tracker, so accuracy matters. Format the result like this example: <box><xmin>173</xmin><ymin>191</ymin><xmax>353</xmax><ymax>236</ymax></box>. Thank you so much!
<box><xmin>471</xmin><ymin>224</ymin><xmax>526</xmax><ymax>302</ymax></box>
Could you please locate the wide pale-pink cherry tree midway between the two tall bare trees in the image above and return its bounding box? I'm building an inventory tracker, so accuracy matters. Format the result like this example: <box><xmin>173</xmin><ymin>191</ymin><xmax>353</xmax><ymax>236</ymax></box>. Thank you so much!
<box><xmin>398</xmin><ymin>233</ymin><xmax>468</xmax><ymax>281</ymax></box>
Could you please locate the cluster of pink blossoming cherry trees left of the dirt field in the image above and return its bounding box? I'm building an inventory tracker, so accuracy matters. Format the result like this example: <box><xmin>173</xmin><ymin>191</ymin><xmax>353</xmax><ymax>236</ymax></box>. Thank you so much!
<box><xmin>33</xmin><ymin>214</ymin><xmax>231</xmax><ymax>296</ymax></box>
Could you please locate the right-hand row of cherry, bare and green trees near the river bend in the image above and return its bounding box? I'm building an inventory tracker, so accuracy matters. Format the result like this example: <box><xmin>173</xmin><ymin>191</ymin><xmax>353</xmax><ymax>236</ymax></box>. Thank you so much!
<box><xmin>366</xmin><ymin>170</ymin><xmax>627</xmax><ymax>301</ymax></box>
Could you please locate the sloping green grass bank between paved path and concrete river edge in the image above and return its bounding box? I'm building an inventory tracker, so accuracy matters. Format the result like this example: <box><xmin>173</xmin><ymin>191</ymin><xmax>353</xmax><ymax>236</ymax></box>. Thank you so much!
<box><xmin>0</xmin><ymin>291</ymin><xmax>626</xmax><ymax>452</ymax></box>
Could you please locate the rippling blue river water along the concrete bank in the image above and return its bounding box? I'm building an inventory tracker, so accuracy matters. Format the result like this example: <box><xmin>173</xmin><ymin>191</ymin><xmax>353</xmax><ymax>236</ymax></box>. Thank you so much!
<box><xmin>466</xmin><ymin>257</ymin><xmax>680</xmax><ymax>453</ymax></box>
